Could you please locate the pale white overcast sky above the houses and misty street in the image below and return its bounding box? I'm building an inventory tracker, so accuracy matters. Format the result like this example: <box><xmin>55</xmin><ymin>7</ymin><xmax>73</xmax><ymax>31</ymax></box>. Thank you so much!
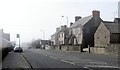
<box><xmin>0</xmin><ymin>0</ymin><xmax>119</xmax><ymax>42</ymax></box>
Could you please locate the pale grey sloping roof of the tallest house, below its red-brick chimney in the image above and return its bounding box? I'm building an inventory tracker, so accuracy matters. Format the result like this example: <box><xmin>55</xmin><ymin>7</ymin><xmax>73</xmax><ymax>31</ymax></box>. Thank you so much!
<box><xmin>69</xmin><ymin>15</ymin><xmax>93</xmax><ymax>28</ymax></box>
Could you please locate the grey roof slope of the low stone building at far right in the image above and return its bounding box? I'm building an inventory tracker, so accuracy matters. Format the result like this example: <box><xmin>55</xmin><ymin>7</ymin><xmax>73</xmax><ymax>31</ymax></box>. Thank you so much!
<box><xmin>104</xmin><ymin>23</ymin><xmax>120</xmax><ymax>33</ymax></box>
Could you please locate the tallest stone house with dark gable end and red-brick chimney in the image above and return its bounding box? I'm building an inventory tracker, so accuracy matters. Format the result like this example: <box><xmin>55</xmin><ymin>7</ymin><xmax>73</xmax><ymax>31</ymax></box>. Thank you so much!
<box><xmin>68</xmin><ymin>10</ymin><xmax>102</xmax><ymax>47</ymax></box>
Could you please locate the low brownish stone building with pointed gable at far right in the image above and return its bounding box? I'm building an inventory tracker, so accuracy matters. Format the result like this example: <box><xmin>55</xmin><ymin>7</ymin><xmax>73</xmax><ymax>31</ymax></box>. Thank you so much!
<box><xmin>94</xmin><ymin>22</ymin><xmax>120</xmax><ymax>47</ymax></box>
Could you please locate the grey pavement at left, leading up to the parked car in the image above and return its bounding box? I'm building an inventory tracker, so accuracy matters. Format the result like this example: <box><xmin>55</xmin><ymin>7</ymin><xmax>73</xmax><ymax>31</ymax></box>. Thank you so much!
<box><xmin>2</xmin><ymin>52</ymin><xmax>30</xmax><ymax>68</ymax></box>
